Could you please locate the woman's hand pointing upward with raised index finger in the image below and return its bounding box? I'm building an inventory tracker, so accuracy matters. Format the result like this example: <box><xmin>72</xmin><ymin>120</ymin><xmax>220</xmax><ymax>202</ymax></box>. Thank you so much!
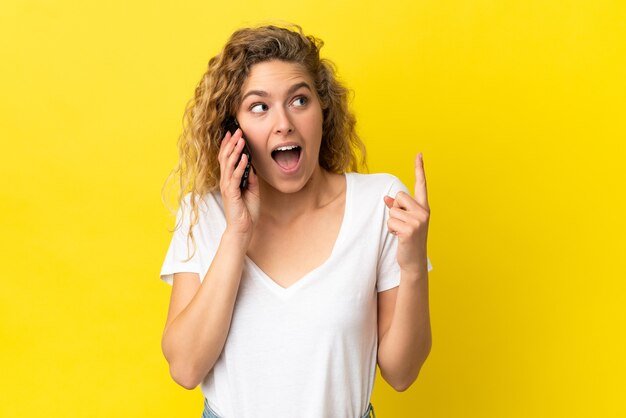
<box><xmin>384</xmin><ymin>153</ymin><xmax>430</xmax><ymax>274</ymax></box>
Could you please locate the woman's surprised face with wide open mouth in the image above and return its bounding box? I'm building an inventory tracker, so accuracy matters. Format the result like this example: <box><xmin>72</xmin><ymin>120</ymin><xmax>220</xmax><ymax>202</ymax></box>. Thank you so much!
<box><xmin>236</xmin><ymin>60</ymin><xmax>323</xmax><ymax>193</ymax></box>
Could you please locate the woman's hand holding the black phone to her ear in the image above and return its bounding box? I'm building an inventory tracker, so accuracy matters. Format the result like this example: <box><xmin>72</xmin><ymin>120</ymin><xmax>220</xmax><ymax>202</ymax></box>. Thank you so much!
<box><xmin>218</xmin><ymin>129</ymin><xmax>261</xmax><ymax>242</ymax></box>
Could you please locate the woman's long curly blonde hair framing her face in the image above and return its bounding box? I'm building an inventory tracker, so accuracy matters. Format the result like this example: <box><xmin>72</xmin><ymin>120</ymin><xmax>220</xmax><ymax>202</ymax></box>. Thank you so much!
<box><xmin>163</xmin><ymin>25</ymin><xmax>366</xmax><ymax>259</ymax></box>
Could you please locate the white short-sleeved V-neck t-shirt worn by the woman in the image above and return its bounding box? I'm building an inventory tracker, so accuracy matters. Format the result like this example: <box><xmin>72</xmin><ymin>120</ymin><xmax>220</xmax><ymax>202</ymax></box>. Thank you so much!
<box><xmin>161</xmin><ymin>173</ymin><xmax>432</xmax><ymax>418</ymax></box>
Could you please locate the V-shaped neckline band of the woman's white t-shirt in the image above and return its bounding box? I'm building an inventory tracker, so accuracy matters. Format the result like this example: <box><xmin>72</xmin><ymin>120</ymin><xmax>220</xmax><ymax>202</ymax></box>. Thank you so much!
<box><xmin>245</xmin><ymin>173</ymin><xmax>352</xmax><ymax>297</ymax></box>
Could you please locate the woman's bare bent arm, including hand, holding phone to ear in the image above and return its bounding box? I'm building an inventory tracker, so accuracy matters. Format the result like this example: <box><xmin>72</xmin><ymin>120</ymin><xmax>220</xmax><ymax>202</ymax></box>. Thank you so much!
<box><xmin>161</xmin><ymin>130</ymin><xmax>260</xmax><ymax>389</ymax></box>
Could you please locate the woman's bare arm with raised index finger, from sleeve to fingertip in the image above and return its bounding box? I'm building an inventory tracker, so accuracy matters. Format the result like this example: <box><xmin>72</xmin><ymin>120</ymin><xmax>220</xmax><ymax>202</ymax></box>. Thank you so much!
<box><xmin>378</xmin><ymin>153</ymin><xmax>432</xmax><ymax>391</ymax></box>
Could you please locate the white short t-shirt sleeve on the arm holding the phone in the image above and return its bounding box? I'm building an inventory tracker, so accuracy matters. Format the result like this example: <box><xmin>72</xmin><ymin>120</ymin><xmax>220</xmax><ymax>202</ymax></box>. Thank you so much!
<box><xmin>161</xmin><ymin>199</ymin><xmax>200</xmax><ymax>285</ymax></box>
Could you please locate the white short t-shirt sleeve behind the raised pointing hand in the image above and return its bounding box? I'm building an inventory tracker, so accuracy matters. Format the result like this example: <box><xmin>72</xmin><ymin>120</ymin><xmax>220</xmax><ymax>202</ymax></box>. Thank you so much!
<box><xmin>376</xmin><ymin>178</ymin><xmax>433</xmax><ymax>292</ymax></box>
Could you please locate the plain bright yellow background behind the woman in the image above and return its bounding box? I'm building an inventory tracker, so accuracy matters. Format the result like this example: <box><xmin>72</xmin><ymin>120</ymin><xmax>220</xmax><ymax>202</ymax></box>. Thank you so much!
<box><xmin>0</xmin><ymin>0</ymin><xmax>626</xmax><ymax>418</ymax></box>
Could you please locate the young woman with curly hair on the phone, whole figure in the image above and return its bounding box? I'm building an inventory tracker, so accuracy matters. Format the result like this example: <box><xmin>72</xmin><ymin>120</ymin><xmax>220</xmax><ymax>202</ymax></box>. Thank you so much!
<box><xmin>161</xmin><ymin>26</ymin><xmax>431</xmax><ymax>418</ymax></box>
